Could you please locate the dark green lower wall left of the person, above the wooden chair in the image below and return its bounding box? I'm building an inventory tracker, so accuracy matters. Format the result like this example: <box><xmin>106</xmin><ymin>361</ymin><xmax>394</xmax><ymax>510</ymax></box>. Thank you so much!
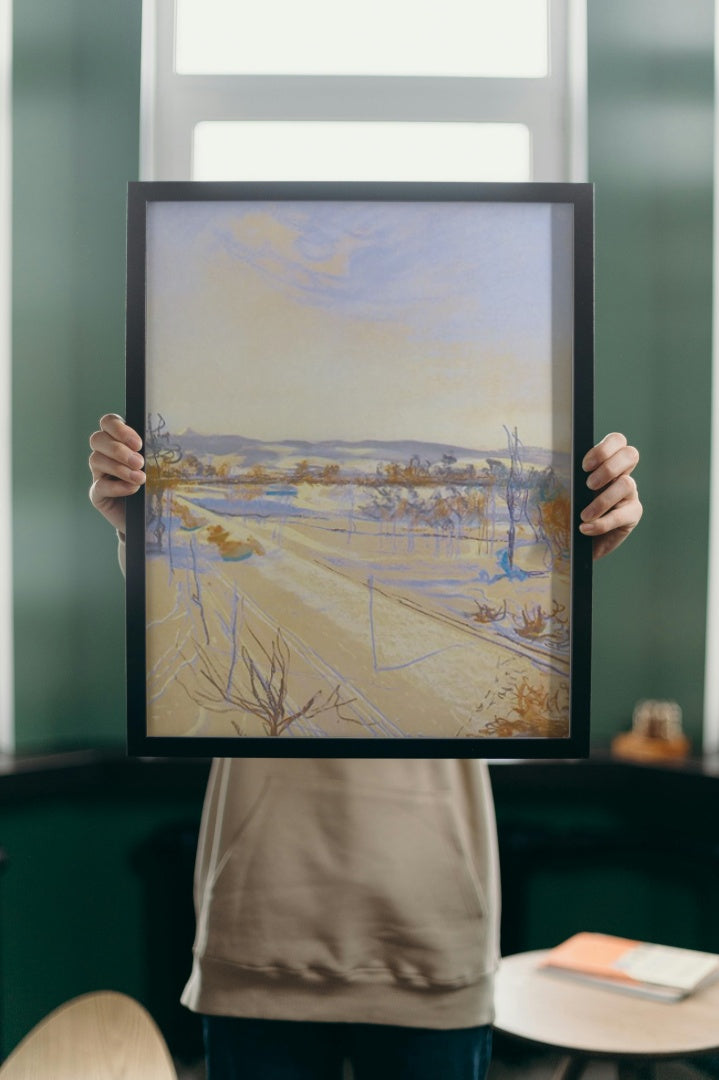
<box><xmin>0</xmin><ymin>777</ymin><xmax>202</xmax><ymax>1058</ymax></box>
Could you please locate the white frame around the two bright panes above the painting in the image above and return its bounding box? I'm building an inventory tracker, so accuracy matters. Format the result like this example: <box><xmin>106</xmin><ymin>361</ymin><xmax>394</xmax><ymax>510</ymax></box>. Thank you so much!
<box><xmin>140</xmin><ymin>0</ymin><xmax>586</xmax><ymax>180</ymax></box>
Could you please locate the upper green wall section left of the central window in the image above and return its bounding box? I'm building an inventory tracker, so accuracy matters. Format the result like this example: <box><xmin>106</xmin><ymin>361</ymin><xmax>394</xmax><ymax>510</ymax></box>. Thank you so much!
<box><xmin>13</xmin><ymin>0</ymin><xmax>140</xmax><ymax>751</ymax></box>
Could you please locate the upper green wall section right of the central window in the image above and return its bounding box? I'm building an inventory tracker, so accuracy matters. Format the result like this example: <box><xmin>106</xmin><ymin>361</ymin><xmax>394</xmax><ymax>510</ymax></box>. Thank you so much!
<box><xmin>588</xmin><ymin>0</ymin><xmax>714</xmax><ymax>748</ymax></box>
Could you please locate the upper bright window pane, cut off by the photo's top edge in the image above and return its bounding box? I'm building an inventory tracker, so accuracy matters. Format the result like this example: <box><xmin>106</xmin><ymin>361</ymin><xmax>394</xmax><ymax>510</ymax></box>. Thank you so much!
<box><xmin>175</xmin><ymin>0</ymin><xmax>547</xmax><ymax>78</ymax></box>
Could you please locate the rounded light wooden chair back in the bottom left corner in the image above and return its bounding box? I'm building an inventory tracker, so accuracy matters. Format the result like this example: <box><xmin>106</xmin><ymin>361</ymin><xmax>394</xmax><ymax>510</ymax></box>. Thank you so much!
<box><xmin>0</xmin><ymin>990</ymin><xmax>177</xmax><ymax>1080</ymax></box>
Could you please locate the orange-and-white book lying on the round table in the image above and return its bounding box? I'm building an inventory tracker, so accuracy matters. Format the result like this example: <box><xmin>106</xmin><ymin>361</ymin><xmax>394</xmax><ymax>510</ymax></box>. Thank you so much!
<box><xmin>541</xmin><ymin>932</ymin><xmax>719</xmax><ymax>1001</ymax></box>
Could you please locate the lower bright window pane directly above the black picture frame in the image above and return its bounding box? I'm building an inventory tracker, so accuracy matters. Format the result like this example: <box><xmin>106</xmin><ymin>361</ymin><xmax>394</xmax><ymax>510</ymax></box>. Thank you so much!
<box><xmin>192</xmin><ymin>121</ymin><xmax>531</xmax><ymax>181</ymax></box>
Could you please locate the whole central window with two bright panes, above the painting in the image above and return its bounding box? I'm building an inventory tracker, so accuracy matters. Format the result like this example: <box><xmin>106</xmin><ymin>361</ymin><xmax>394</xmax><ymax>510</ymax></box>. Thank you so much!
<box><xmin>141</xmin><ymin>0</ymin><xmax>585</xmax><ymax>180</ymax></box>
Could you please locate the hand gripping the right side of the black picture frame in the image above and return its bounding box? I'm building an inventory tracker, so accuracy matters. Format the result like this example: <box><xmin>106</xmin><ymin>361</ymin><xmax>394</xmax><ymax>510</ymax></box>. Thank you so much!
<box><xmin>580</xmin><ymin>431</ymin><xmax>643</xmax><ymax>559</ymax></box>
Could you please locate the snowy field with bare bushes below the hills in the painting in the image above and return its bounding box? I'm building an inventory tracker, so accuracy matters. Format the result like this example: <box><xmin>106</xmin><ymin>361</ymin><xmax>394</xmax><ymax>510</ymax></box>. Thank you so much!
<box><xmin>148</xmin><ymin>434</ymin><xmax>569</xmax><ymax>738</ymax></box>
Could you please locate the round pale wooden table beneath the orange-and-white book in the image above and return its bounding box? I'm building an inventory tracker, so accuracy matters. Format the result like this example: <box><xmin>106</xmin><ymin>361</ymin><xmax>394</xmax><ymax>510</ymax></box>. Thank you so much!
<box><xmin>494</xmin><ymin>950</ymin><xmax>719</xmax><ymax>1080</ymax></box>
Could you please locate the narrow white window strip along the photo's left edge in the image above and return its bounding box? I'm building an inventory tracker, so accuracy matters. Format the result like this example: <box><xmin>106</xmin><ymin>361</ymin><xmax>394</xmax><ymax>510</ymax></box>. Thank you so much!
<box><xmin>0</xmin><ymin>0</ymin><xmax>15</xmax><ymax>754</ymax></box>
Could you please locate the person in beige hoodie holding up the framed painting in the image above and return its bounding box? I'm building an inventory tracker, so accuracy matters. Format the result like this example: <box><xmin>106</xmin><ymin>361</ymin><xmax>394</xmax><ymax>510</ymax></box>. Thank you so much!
<box><xmin>90</xmin><ymin>414</ymin><xmax>642</xmax><ymax>1080</ymax></box>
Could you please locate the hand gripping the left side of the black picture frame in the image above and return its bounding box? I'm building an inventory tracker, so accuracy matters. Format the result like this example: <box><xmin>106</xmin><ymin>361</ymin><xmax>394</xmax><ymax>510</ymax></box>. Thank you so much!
<box><xmin>89</xmin><ymin>413</ymin><xmax>146</xmax><ymax>534</ymax></box>
